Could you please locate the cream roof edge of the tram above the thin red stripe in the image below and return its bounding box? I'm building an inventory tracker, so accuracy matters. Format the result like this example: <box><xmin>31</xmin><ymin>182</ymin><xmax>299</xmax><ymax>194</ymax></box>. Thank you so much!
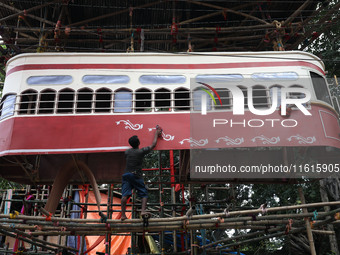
<box><xmin>6</xmin><ymin>51</ymin><xmax>324</xmax><ymax>71</ymax></box>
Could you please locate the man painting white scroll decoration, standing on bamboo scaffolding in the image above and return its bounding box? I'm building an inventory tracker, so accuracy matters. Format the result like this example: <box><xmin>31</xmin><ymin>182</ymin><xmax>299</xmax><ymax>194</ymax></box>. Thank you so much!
<box><xmin>121</xmin><ymin>126</ymin><xmax>162</xmax><ymax>220</ymax></box>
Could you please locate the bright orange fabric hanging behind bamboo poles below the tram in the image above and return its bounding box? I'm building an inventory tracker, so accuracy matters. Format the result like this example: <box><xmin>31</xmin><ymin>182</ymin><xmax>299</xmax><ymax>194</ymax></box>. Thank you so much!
<box><xmin>80</xmin><ymin>188</ymin><xmax>131</xmax><ymax>255</ymax></box>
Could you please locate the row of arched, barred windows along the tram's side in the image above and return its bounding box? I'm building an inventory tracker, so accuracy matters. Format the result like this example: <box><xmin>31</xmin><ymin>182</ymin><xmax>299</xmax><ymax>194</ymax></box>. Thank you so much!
<box><xmin>0</xmin><ymin>85</ymin><xmax>310</xmax><ymax>119</ymax></box>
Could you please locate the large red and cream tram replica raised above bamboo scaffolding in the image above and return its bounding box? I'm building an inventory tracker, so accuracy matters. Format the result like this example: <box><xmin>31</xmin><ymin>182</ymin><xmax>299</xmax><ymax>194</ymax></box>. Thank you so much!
<box><xmin>0</xmin><ymin>52</ymin><xmax>340</xmax><ymax>183</ymax></box>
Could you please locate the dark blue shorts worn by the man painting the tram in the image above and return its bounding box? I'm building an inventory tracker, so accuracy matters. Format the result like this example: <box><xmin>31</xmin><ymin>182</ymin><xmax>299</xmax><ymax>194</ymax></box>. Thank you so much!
<box><xmin>122</xmin><ymin>173</ymin><xmax>148</xmax><ymax>198</ymax></box>
